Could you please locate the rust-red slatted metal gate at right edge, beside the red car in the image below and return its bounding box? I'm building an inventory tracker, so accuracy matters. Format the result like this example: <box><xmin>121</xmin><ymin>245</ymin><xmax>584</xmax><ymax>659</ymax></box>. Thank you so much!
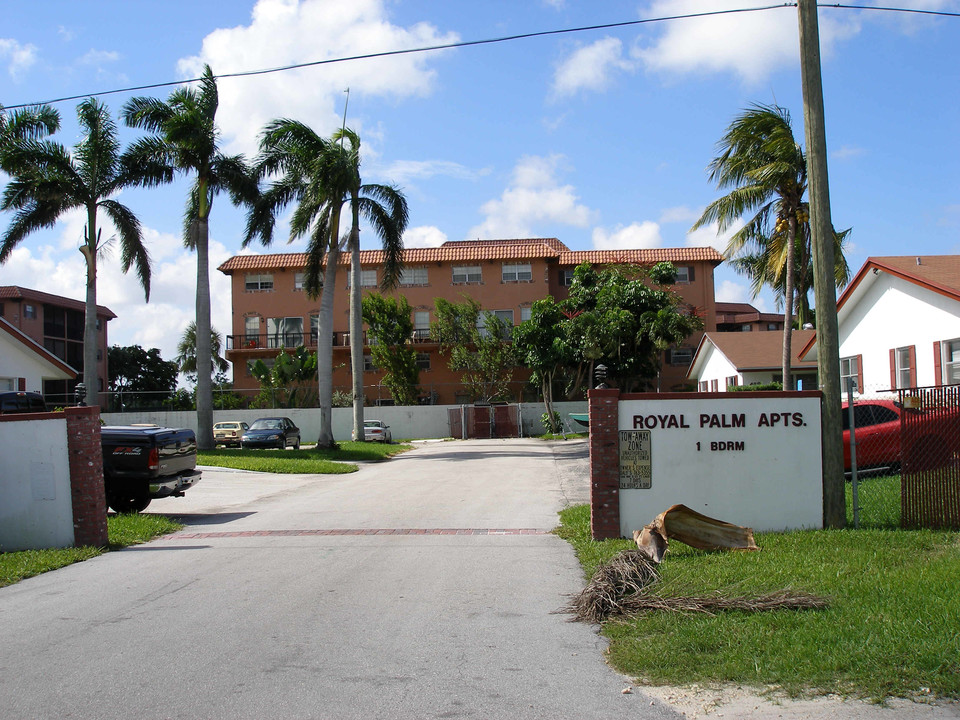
<box><xmin>898</xmin><ymin>385</ymin><xmax>960</xmax><ymax>529</ymax></box>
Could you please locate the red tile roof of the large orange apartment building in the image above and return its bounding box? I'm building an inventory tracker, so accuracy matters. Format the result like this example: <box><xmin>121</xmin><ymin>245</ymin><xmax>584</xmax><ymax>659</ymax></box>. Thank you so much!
<box><xmin>217</xmin><ymin>238</ymin><xmax>723</xmax><ymax>275</ymax></box>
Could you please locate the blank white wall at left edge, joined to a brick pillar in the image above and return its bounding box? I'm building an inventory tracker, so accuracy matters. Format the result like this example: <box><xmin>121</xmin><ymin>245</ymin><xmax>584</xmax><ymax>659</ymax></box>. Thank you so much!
<box><xmin>0</xmin><ymin>418</ymin><xmax>74</xmax><ymax>551</ymax></box>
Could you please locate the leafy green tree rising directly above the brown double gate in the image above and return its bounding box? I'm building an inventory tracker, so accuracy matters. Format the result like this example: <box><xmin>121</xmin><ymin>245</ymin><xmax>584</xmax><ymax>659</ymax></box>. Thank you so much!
<box><xmin>430</xmin><ymin>298</ymin><xmax>517</xmax><ymax>402</ymax></box>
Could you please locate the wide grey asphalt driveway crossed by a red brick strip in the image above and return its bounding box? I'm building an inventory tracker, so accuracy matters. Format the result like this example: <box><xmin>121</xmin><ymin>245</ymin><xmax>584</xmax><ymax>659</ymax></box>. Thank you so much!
<box><xmin>0</xmin><ymin>440</ymin><xmax>680</xmax><ymax>719</ymax></box>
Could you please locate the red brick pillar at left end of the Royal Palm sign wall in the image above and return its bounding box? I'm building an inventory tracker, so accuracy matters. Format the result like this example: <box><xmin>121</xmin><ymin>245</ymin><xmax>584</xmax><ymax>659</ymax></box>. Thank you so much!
<box><xmin>587</xmin><ymin>388</ymin><xmax>620</xmax><ymax>540</ymax></box>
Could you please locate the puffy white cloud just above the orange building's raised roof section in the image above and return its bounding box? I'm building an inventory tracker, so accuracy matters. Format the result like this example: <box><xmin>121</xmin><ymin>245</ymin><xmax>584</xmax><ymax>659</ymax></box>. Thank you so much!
<box><xmin>467</xmin><ymin>155</ymin><xmax>593</xmax><ymax>239</ymax></box>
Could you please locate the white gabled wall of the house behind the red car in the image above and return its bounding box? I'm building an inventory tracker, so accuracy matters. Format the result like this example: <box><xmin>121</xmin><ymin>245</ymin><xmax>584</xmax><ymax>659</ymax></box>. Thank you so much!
<box><xmin>839</xmin><ymin>272</ymin><xmax>960</xmax><ymax>393</ymax></box>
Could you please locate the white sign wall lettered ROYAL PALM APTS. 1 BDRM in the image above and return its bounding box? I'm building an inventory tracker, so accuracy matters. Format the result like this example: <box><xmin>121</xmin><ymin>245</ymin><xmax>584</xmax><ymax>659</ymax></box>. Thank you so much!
<box><xmin>618</xmin><ymin>393</ymin><xmax>823</xmax><ymax>537</ymax></box>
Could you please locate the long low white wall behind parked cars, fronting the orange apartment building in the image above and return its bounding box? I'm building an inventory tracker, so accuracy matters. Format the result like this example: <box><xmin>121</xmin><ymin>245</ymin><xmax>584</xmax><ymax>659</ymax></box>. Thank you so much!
<box><xmin>101</xmin><ymin>401</ymin><xmax>587</xmax><ymax>442</ymax></box>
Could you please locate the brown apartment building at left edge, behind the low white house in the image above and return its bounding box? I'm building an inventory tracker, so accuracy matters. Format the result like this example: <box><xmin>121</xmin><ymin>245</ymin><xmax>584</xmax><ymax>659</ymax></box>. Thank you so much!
<box><xmin>0</xmin><ymin>285</ymin><xmax>116</xmax><ymax>409</ymax></box>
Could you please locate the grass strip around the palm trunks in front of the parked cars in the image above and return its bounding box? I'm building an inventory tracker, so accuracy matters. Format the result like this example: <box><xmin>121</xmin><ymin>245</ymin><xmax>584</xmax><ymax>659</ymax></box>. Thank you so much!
<box><xmin>197</xmin><ymin>441</ymin><xmax>413</xmax><ymax>475</ymax></box>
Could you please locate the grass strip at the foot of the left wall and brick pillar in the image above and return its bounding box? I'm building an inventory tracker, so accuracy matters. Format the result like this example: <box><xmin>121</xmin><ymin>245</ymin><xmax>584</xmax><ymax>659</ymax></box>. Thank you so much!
<box><xmin>0</xmin><ymin>514</ymin><xmax>183</xmax><ymax>587</ymax></box>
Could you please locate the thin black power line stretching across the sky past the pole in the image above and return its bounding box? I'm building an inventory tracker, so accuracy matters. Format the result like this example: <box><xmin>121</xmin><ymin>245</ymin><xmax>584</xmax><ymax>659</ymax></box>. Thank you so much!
<box><xmin>6</xmin><ymin>0</ymin><xmax>960</xmax><ymax>110</ymax></box>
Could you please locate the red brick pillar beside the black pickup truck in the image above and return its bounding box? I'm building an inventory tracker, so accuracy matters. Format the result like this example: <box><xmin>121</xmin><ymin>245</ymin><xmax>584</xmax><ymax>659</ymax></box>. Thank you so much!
<box><xmin>64</xmin><ymin>405</ymin><xmax>108</xmax><ymax>547</ymax></box>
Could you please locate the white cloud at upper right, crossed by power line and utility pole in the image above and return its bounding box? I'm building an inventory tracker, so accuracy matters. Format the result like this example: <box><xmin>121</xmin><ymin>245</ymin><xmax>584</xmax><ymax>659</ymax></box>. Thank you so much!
<box><xmin>634</xmin><ymin>0</ymin><xmax>860</xmax><ymax>85</ymax></box>
